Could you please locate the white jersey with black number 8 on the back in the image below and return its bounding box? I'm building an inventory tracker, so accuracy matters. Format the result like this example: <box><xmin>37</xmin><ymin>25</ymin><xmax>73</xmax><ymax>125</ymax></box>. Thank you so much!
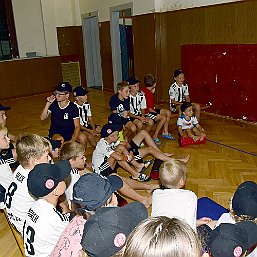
<box><xmin>5</xmin><ymin>165</ymin><xmax>35</xmax><ymax>234</ymax></box>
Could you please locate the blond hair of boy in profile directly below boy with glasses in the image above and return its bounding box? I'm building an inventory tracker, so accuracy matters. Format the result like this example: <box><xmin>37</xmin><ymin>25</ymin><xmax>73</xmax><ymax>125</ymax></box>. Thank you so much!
<box><xmin>60</xmin><ymin>141</ymin><xmax>85</xmax><ymax>160</ymax></box>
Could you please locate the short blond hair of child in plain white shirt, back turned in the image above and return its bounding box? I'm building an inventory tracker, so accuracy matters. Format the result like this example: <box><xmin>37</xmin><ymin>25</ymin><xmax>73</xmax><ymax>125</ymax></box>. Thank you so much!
<box><xmin>160</xmin><ymin>159</ymin><xmax>187</xmax><ymax>188</ymax></box>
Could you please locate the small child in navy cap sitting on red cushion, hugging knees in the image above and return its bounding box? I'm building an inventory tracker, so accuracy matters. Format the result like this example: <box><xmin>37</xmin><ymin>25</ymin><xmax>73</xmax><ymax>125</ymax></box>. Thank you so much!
<box><xmin>177</xmin><ymin>102</ymin><xmax>206</xmax><ymax>142</ymax></box>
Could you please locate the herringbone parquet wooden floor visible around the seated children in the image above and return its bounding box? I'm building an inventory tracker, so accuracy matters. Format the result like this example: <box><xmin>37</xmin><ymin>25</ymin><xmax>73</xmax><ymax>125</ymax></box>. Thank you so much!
<box><xmin>0</xmin><ymin>89</ymin><xmax>257</xmax><ymax>254</ymax></box>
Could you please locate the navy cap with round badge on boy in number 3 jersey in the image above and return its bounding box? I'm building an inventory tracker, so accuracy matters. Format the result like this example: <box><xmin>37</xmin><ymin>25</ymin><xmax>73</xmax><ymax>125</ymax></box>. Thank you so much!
<box><xmin>28</xmin><ymin>160</ymin><xmax>71</xmax><ymax>198</ymax></box>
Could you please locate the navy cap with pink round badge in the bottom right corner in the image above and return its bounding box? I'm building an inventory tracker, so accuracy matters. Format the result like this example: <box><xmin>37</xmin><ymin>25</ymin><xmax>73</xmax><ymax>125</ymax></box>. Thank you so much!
<box><xmin>208</xmin><ymin>221</ymin><xmax>257</xmax><ymax>257</ymax></box>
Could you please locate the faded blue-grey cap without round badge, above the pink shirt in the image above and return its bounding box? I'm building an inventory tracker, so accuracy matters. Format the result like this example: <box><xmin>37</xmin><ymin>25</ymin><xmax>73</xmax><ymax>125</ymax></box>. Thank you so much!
<box><xmin>73</xmin><ymin>173</ymin><xmax>123</xmax><ymax>211</ymax></box>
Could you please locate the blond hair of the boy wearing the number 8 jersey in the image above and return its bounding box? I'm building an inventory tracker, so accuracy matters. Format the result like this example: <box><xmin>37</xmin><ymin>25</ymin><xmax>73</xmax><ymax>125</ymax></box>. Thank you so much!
<box><xmin>16</xmin><ymin>133</ymin><xmax>52</xmax><ymax>167</ymax></box>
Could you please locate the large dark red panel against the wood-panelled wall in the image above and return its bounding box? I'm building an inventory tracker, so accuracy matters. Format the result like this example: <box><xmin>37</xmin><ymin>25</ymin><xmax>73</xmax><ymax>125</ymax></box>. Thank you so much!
<box><xmin>181</xmin><ymin>45</ymin><xmax>257</xmax><ymax>121</ymax></box>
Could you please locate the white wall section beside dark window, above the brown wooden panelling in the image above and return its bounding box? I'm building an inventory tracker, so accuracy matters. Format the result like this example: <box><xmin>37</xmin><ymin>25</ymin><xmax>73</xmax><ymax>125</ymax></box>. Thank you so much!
<box><xmin>12</xmin><ymin>0</ymin><xmax>59</xmax><ymax>58</ymax></box>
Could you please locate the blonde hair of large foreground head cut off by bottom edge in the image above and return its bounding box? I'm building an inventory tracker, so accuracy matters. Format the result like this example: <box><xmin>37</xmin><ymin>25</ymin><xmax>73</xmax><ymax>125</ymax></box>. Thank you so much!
<box><xmin>119</xmin><ymin>216</ymin><xmax>201</xmax><ymax>257</ymax></box>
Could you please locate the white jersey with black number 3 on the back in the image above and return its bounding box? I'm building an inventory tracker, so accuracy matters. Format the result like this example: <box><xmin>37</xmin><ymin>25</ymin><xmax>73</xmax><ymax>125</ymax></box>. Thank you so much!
<box><xmin>23</xmin><ymin>199</ymin><xmax>70</xmax><ymax>257</ymax></box>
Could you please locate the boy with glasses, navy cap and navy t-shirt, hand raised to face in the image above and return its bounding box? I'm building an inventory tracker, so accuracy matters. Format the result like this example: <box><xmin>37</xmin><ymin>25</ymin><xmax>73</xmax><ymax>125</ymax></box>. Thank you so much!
<box><xmin>40</xmin><ymin>82</ymin><xmax>80</xmax><ymax>143</ymax></box>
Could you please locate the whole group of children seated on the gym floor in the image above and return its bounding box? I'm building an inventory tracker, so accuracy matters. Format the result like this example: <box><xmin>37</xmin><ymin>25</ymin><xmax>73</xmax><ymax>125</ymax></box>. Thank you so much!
<box><xmin>0</xmin><ymin>70</ymin><xmax>254</xmax><ymax>257</ymax></box>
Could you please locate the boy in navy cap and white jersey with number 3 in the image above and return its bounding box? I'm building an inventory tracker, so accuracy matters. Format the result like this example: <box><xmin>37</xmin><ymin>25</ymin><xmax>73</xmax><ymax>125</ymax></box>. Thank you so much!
<box><xmin>23</xmin><ymin>161</ymin><xmax>71</xmax><ymax>257</ymax></box>
